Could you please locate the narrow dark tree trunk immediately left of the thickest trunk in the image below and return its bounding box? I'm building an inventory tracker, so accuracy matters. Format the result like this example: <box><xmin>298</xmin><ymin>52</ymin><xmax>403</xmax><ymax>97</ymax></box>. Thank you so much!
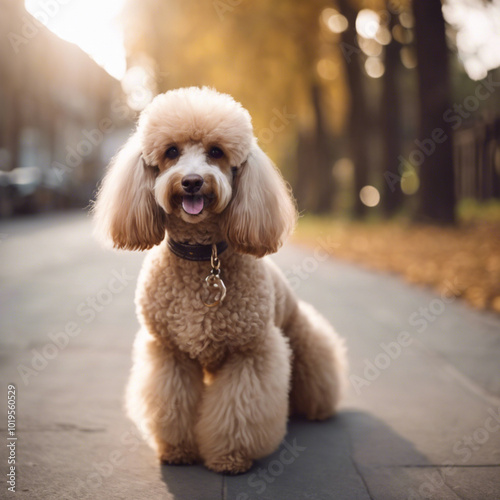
<box><xmin>380</xmin><ymin>11</ymin><xmax>403</xmax><ymax>216</ymax></box>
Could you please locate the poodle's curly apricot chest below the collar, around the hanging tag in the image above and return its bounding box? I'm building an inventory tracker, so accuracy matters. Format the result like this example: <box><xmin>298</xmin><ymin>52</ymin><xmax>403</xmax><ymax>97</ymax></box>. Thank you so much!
<box><xmin>138</xmin><ymin>256</ymin><xmax>267</xmax><ymax>367</ymax></box>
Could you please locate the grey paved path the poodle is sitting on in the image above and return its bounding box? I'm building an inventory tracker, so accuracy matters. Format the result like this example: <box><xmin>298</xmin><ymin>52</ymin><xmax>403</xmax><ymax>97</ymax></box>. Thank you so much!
<box><xmin>0</xmin><ymin>213</ymin><xmax>500</xmax><ymax>500</ymax></box>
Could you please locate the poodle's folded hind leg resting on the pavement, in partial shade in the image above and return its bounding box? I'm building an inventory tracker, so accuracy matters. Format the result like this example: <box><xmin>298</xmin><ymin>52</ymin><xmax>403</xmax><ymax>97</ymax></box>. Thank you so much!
<box><xmin>285</xmin><ymin>301</ymin><xmax>347</xmax><ymax>420</ymax></box>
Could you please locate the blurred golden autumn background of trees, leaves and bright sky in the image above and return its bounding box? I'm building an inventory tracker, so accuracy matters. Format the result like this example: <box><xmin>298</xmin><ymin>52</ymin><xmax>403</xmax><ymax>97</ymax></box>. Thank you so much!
<box><xmin>0</xmin><ymin>0</ymin><xmax>500</xmax><ymax>311</ymax></box>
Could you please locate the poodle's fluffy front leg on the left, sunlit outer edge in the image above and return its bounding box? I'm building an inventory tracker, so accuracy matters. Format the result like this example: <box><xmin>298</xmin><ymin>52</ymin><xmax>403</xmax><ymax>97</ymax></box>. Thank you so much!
<box><xmin>127</xmin><ymin>330</ymin><xmax>203</xmax><ymax>464</ymax></box>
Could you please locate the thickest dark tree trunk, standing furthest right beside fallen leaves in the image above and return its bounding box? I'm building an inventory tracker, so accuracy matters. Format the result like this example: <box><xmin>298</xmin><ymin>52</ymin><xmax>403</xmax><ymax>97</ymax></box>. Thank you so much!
<box><xmin>413</xmin><ymin>0</ymin><xmax>455</xmax><ymax>224</ymax></box>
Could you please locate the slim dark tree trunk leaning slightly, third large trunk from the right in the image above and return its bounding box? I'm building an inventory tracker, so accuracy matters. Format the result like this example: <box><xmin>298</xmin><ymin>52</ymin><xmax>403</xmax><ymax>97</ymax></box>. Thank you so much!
<box><xmin>337</xmin><ymin>0</ymin><xmax>369</xmax><ymax>217</ymax></box>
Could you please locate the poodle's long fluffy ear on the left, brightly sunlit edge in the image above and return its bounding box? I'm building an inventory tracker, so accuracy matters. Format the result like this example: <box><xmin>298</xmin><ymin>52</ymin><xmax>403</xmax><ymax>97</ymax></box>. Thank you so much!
<box><xmin>93</xmin><ymin>135</ymin><xmax>165</xmax><ymax>250</ymax></box>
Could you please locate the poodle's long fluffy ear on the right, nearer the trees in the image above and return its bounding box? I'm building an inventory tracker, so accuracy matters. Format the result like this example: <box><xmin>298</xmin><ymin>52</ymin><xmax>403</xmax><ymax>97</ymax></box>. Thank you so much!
<box><xmin>224</xmin><ymin>140</ymin><xmax>297</xmax><ymax>257</ymax></box>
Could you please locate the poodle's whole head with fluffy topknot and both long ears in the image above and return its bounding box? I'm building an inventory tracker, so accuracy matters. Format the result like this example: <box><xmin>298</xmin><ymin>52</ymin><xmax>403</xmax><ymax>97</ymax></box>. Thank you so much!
<box><xmin>94</xmin><ymin>87</ymin><xmax>296</xmax><ymax>256</ymax></box>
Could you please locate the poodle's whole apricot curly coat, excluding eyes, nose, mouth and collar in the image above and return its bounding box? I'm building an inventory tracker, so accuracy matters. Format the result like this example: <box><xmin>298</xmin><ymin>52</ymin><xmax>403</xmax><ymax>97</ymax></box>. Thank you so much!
<box><xmin>94</xmin><ymin>88</ymin><xmax>346</xmax><ymax>473</ymax></box>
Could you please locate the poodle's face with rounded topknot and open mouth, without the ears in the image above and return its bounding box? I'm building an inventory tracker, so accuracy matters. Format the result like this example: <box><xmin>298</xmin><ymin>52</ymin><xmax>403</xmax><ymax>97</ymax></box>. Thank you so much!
<box><xmin>138</xmin><ymin>89</ymin><xmax>253</xmax><ymax>224</ymax></box>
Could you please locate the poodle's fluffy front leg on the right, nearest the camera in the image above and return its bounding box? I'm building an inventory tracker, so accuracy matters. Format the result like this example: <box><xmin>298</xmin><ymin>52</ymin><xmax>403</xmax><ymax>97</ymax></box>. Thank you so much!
<box><xmin>196</xmin><ymin>326</ymin><xmax>290</xmax><ymax>474</ymax></box>
